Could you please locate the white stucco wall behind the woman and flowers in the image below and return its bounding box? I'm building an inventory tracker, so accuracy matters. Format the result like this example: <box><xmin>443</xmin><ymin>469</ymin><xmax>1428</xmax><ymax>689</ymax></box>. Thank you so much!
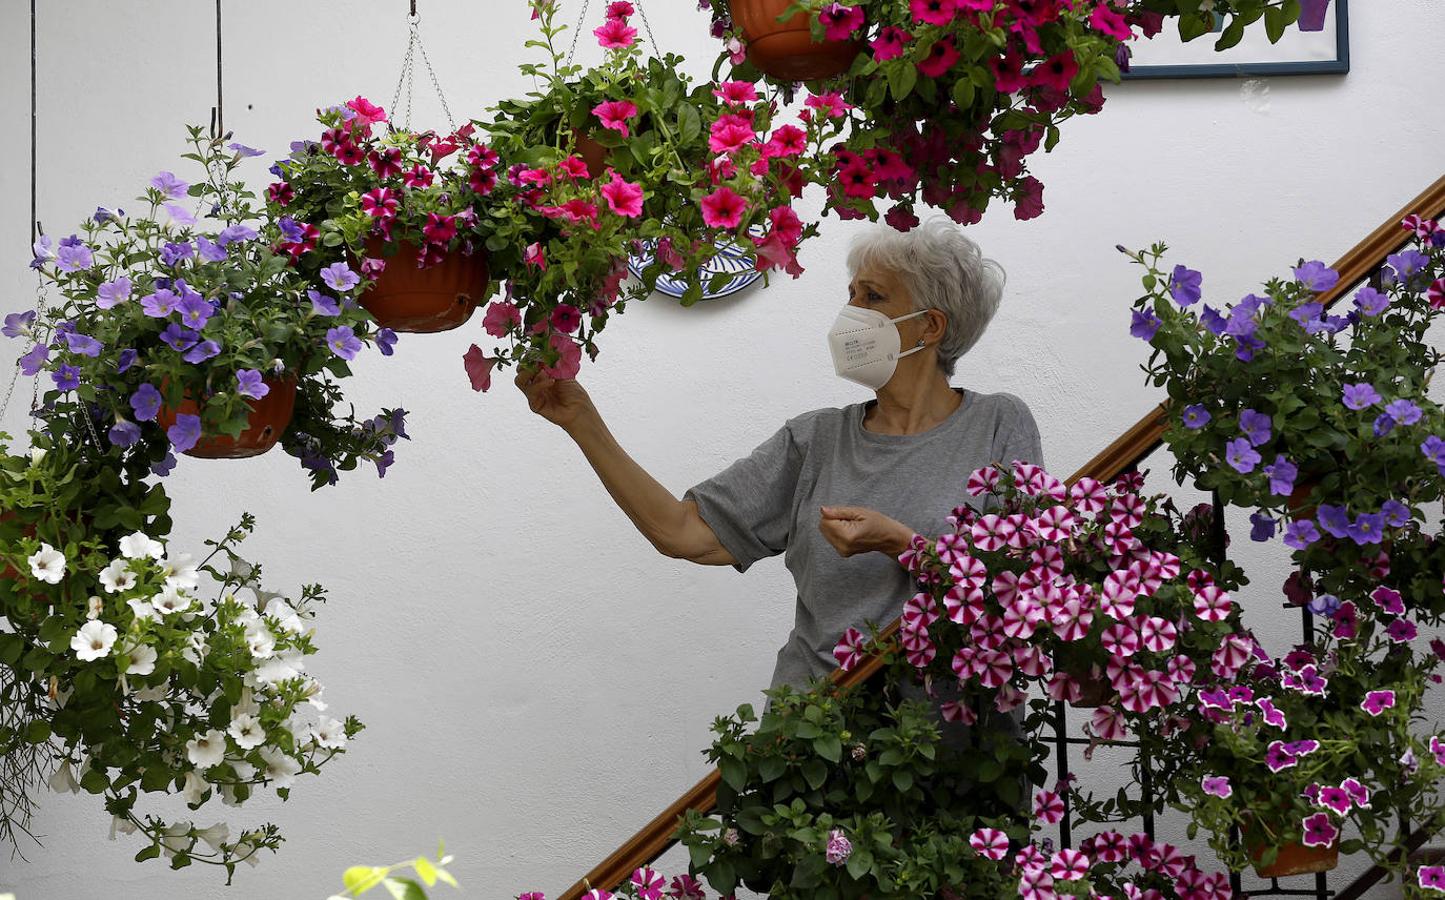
<box><xmin>0</xmin><ymin>0</ymin><xmax>1445</xmax><ymax>900</ymax></box>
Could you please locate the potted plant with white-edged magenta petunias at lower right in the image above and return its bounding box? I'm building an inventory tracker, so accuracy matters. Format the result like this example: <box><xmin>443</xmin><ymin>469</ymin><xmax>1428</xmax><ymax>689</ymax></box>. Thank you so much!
<box><xmin>1161</xmin><ymin>618</ymin><xmax>1445</xmax><ymax>877</ymax></box>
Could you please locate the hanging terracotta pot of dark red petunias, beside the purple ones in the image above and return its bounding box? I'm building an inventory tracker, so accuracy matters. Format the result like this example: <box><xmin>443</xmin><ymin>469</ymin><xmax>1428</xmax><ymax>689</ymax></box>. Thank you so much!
<box><xmin>266</xmin><ymin>97</ymin><xmax>500</xmax><ymax>332</ymax></box>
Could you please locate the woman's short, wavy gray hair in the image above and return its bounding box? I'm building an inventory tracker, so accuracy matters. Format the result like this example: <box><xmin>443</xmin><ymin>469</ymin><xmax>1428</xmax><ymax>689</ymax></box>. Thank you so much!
<box><xmin>848</xmin><ymin>215</ymin><xmax>1006</xmax><ymax>377</ymax></box>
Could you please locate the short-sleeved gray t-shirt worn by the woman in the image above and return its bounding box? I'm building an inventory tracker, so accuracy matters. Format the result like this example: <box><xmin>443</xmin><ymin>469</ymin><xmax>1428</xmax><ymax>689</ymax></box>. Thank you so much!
<box><xmin>683</xmin><ymin>390</ymin><xmax>1043</xmax><ymax>688</ymax></box>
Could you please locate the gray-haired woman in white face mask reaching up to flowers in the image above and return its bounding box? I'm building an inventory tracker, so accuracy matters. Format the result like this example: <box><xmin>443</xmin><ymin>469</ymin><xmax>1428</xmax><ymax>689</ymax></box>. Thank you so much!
<box><xmin>516</xmin><ymin>220</ymin><xmax>1043</xmax><ymax>688</ymax></box>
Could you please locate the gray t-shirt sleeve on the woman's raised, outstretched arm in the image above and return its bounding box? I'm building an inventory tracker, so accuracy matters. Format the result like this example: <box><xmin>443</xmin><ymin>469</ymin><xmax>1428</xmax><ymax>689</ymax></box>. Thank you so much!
<box><xmin>682</xmin><ymin>426</ymin><xmax>802</xmax><ymax>572</ymax></box>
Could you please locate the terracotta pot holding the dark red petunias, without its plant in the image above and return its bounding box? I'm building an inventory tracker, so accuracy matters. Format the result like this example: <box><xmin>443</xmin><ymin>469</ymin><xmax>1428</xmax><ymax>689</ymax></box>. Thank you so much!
<box><xmin>360</xmin><ymin>238</ymin><xmax>491</xmax><ymax>334</ymax></box>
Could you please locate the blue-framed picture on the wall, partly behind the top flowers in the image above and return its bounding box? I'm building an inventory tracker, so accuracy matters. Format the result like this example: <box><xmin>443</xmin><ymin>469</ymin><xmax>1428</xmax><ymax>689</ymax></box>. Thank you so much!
<box><xmin>1123</xmin><ymin>0</ymin><xmax>1350</xmax><ymax>81</ymax></box>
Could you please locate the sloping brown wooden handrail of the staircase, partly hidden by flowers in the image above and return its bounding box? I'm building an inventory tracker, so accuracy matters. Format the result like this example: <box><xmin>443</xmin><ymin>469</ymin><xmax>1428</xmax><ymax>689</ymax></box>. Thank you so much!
<box><xmin>558</xmin><ymin>175</ymin><xmax>1445</xmax><ymax>900</ymax></box>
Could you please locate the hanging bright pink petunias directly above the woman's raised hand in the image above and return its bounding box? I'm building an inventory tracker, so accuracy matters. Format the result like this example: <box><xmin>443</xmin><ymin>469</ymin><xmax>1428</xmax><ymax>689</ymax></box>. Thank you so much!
<box><xmin>470</xmin><ymin>1</ymin><xmax>835</xmax><ymax>387</ymax></box>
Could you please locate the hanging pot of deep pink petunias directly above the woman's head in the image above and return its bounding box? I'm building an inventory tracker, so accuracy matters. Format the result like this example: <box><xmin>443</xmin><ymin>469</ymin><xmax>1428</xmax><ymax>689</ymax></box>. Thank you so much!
<box><xmin>709</xmin><ymin>0</ymin><xmax>1298</xmax><ymax>231</ymax></box>
